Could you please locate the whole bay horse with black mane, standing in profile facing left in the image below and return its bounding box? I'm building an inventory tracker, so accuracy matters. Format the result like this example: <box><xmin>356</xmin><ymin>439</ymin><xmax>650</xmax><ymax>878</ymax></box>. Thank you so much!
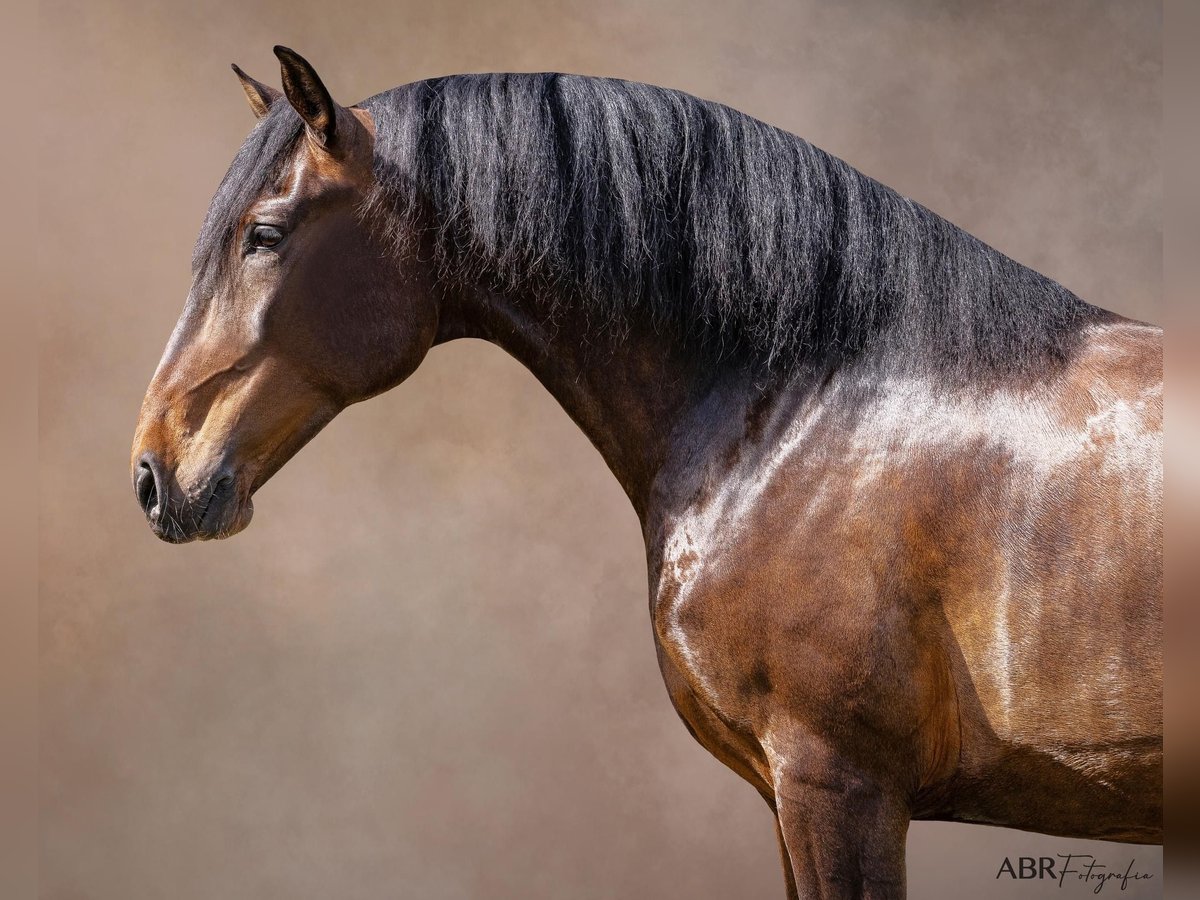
<box><xmin>132</xmin><ymin>47</ymin><xmax>1163</xmax><ymax>898</ymax></box>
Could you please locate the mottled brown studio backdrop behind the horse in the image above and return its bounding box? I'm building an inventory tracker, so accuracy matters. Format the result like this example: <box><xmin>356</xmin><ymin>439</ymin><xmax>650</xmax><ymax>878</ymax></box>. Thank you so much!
<box><xmin>39</xmin><ymin>0</ymin><xmax>1162</xmax><ymax>900</ymax></box>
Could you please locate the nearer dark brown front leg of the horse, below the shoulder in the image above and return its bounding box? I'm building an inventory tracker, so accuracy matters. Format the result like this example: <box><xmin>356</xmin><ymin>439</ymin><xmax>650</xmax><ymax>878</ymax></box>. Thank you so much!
<box><xmin>772</xmin><ymin>742</ymin><xmax>910</xmax><ymax>900</ymax></box>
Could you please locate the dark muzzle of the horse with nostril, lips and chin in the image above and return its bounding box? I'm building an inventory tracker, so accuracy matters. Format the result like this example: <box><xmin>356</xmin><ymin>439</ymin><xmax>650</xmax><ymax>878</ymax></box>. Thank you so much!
<box><xmin>133</xmin><ymin>450</ymin><xmax>253</xmax><ymax>544</ymax></box>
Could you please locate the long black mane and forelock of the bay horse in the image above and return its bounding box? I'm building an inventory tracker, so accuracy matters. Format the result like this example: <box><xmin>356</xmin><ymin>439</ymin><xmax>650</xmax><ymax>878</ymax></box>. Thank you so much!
<box><xmin>198</xmin><ymin>73</ymin><xmax>1104</xmax><ymax>377</ymax></box>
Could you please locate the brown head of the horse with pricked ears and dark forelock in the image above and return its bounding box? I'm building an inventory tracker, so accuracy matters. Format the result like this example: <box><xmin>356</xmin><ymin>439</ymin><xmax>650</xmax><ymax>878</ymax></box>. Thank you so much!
<box><xmin>131</xmin><ymin>47</ymin><xmax>437</xmax><ymax>542</ymax></box>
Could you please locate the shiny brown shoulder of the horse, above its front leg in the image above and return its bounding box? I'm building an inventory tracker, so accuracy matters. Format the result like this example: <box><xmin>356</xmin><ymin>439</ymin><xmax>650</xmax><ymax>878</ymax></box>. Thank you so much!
<box><xmin>650</xmin><ymin>393</ymin><xmax>974</xmax><ymax>790</ymax></box>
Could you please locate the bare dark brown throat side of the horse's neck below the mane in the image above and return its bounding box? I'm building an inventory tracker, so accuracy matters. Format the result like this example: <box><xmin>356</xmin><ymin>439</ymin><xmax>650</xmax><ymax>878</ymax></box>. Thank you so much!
<box><xmin>437</xmin><ymin>282</ymin><xmax>714</xmax><ymax>524</ymax></box>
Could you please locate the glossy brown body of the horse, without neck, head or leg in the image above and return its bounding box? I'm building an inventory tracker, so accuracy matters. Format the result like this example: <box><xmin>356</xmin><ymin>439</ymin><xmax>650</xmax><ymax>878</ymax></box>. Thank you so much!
<box><xmin>650</xmin><ymin>319</ymin><xmax>1162</xmax><ymax>868</ymax></box>
